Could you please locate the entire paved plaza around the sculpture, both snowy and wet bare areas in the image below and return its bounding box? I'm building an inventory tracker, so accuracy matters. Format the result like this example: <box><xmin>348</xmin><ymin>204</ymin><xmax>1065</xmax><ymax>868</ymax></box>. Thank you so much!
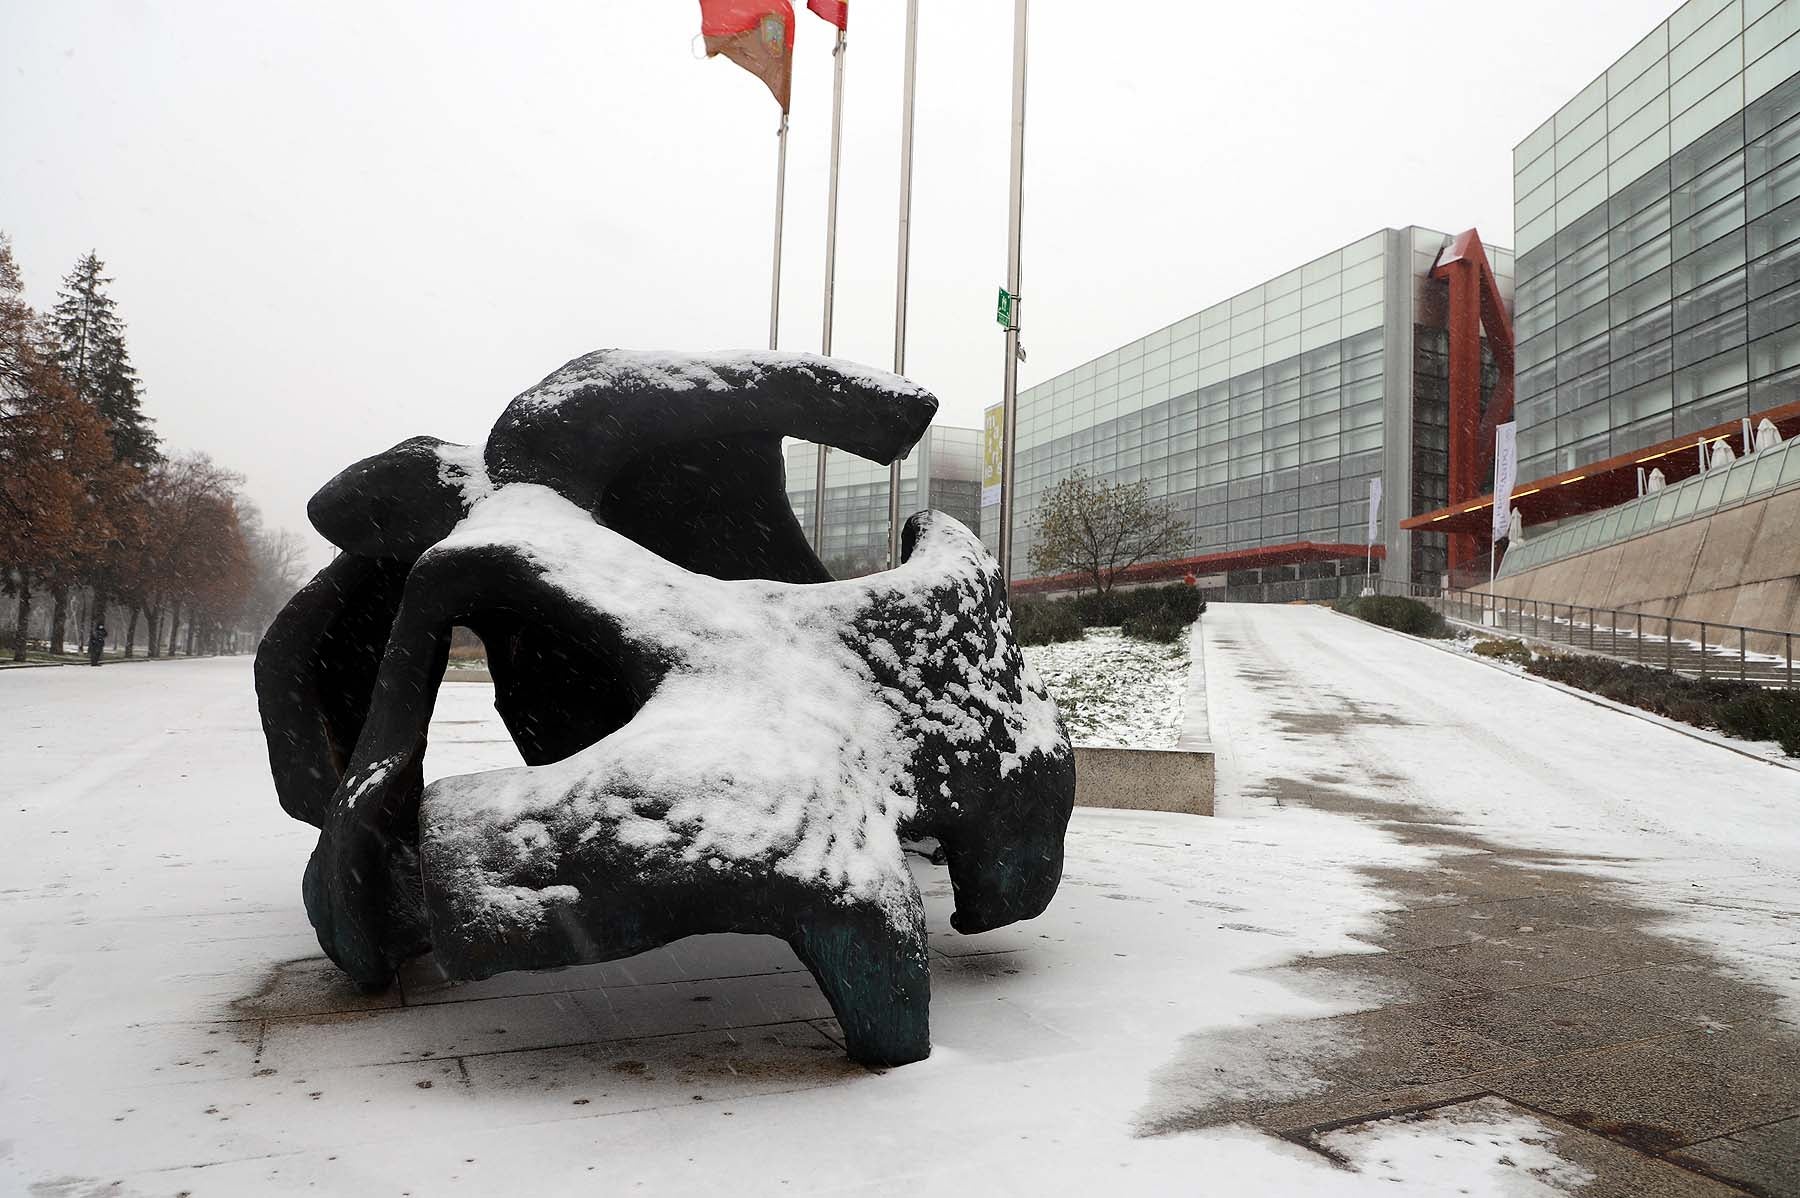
<box><xmin>0</xmin><ymin>606</ymin><xmax>1800</xmax><ymax>1194</ymax></box>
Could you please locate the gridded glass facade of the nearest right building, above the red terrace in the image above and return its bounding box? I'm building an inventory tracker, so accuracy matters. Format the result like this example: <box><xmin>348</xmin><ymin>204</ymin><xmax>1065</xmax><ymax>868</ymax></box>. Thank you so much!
<box><xmin>1514</xmin><ymin>0</ymin><xmax>1800</xmax><ymax>480</ymax></box>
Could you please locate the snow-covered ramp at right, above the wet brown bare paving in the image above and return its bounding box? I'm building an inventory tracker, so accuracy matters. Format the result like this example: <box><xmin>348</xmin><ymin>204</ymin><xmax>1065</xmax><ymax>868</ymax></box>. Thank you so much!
<box><xmin>1206</xmin><ymin>604</ymin><xmax>1800</xmax><ymax>1022</ymax></box>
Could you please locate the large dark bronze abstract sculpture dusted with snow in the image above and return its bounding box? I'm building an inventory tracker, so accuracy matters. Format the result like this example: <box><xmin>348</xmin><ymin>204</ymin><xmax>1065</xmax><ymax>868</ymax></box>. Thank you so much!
<box><xmin>257</xmin><ymin>351</ymin><xmax>1075</xmax><ymax>1065</ymax></box>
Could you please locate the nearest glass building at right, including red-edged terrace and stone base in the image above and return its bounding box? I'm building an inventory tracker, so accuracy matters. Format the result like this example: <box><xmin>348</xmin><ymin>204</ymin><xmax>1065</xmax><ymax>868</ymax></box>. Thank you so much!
<box><xmin>1409</xmin><ymin>0</ymin><xmax>1800</xmax><ymax>635</ymax></box>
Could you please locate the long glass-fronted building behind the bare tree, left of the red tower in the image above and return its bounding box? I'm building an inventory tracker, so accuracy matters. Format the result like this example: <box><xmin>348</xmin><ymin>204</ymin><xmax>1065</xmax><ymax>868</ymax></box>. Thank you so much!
<box><xmin>983</xmin><ymin>227</ymin><xmax>1512</xmax><ymax>599</ymax></box>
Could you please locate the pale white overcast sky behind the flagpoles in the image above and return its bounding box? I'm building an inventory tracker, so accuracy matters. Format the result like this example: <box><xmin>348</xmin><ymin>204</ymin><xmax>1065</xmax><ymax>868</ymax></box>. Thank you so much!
<box><xmin>0</xmin><ymin>0</ymin><xmax>1674</xmax><ymax>559</ymax></box>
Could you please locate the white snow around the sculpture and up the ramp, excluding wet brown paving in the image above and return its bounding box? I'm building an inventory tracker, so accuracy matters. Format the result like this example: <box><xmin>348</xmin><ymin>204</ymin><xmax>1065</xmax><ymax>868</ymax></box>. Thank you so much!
<box><xmin>0</xmin><ymin>604</ymin><xmax>1800</xmax><ymax>1194</ymax></box>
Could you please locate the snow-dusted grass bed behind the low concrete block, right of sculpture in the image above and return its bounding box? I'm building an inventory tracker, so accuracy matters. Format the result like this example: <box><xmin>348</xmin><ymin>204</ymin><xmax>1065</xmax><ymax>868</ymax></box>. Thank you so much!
<box><xmin>1024</xmin><ymin>628</ymin><xmax>1188</xmax><ymax>748</ymax></box>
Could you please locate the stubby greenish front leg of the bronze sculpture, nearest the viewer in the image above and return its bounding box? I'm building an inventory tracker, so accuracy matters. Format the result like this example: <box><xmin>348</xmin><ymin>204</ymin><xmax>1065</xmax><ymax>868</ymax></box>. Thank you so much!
<box><xmin>788</xmin><ymin>907</ymin><xmax>931</xmax><ymax>1067</ymax></box>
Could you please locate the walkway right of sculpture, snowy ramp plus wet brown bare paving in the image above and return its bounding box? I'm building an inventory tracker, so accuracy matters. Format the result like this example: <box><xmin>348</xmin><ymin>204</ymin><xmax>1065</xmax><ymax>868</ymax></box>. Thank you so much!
<box><xmin>1180</xmin><ymin>606</ymin><xmax>1800</xmax><ymax>1196</ymax></box>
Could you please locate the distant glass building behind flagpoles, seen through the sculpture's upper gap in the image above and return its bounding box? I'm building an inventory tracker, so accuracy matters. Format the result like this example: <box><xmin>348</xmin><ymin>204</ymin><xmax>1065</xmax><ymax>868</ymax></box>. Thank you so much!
<box><xmin>783</xmin><ymin>425</ymin><xmax>981</xmax><ymax>577</ymax></box>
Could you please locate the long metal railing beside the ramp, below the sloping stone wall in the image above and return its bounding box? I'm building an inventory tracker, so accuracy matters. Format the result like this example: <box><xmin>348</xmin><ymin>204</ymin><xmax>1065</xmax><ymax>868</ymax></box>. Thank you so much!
<box><xmin>1381</xmin><ymin>583</ymin><xmax>1796</xmax><ymax>691</ymax></box>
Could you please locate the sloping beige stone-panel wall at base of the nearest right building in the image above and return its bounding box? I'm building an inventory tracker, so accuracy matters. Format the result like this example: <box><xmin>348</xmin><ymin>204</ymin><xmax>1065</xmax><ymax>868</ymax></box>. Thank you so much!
<box><xmin>1480</xmin><ymin>487</ymin><xmax>1800</xmax><ymax>653</ymax></box>
